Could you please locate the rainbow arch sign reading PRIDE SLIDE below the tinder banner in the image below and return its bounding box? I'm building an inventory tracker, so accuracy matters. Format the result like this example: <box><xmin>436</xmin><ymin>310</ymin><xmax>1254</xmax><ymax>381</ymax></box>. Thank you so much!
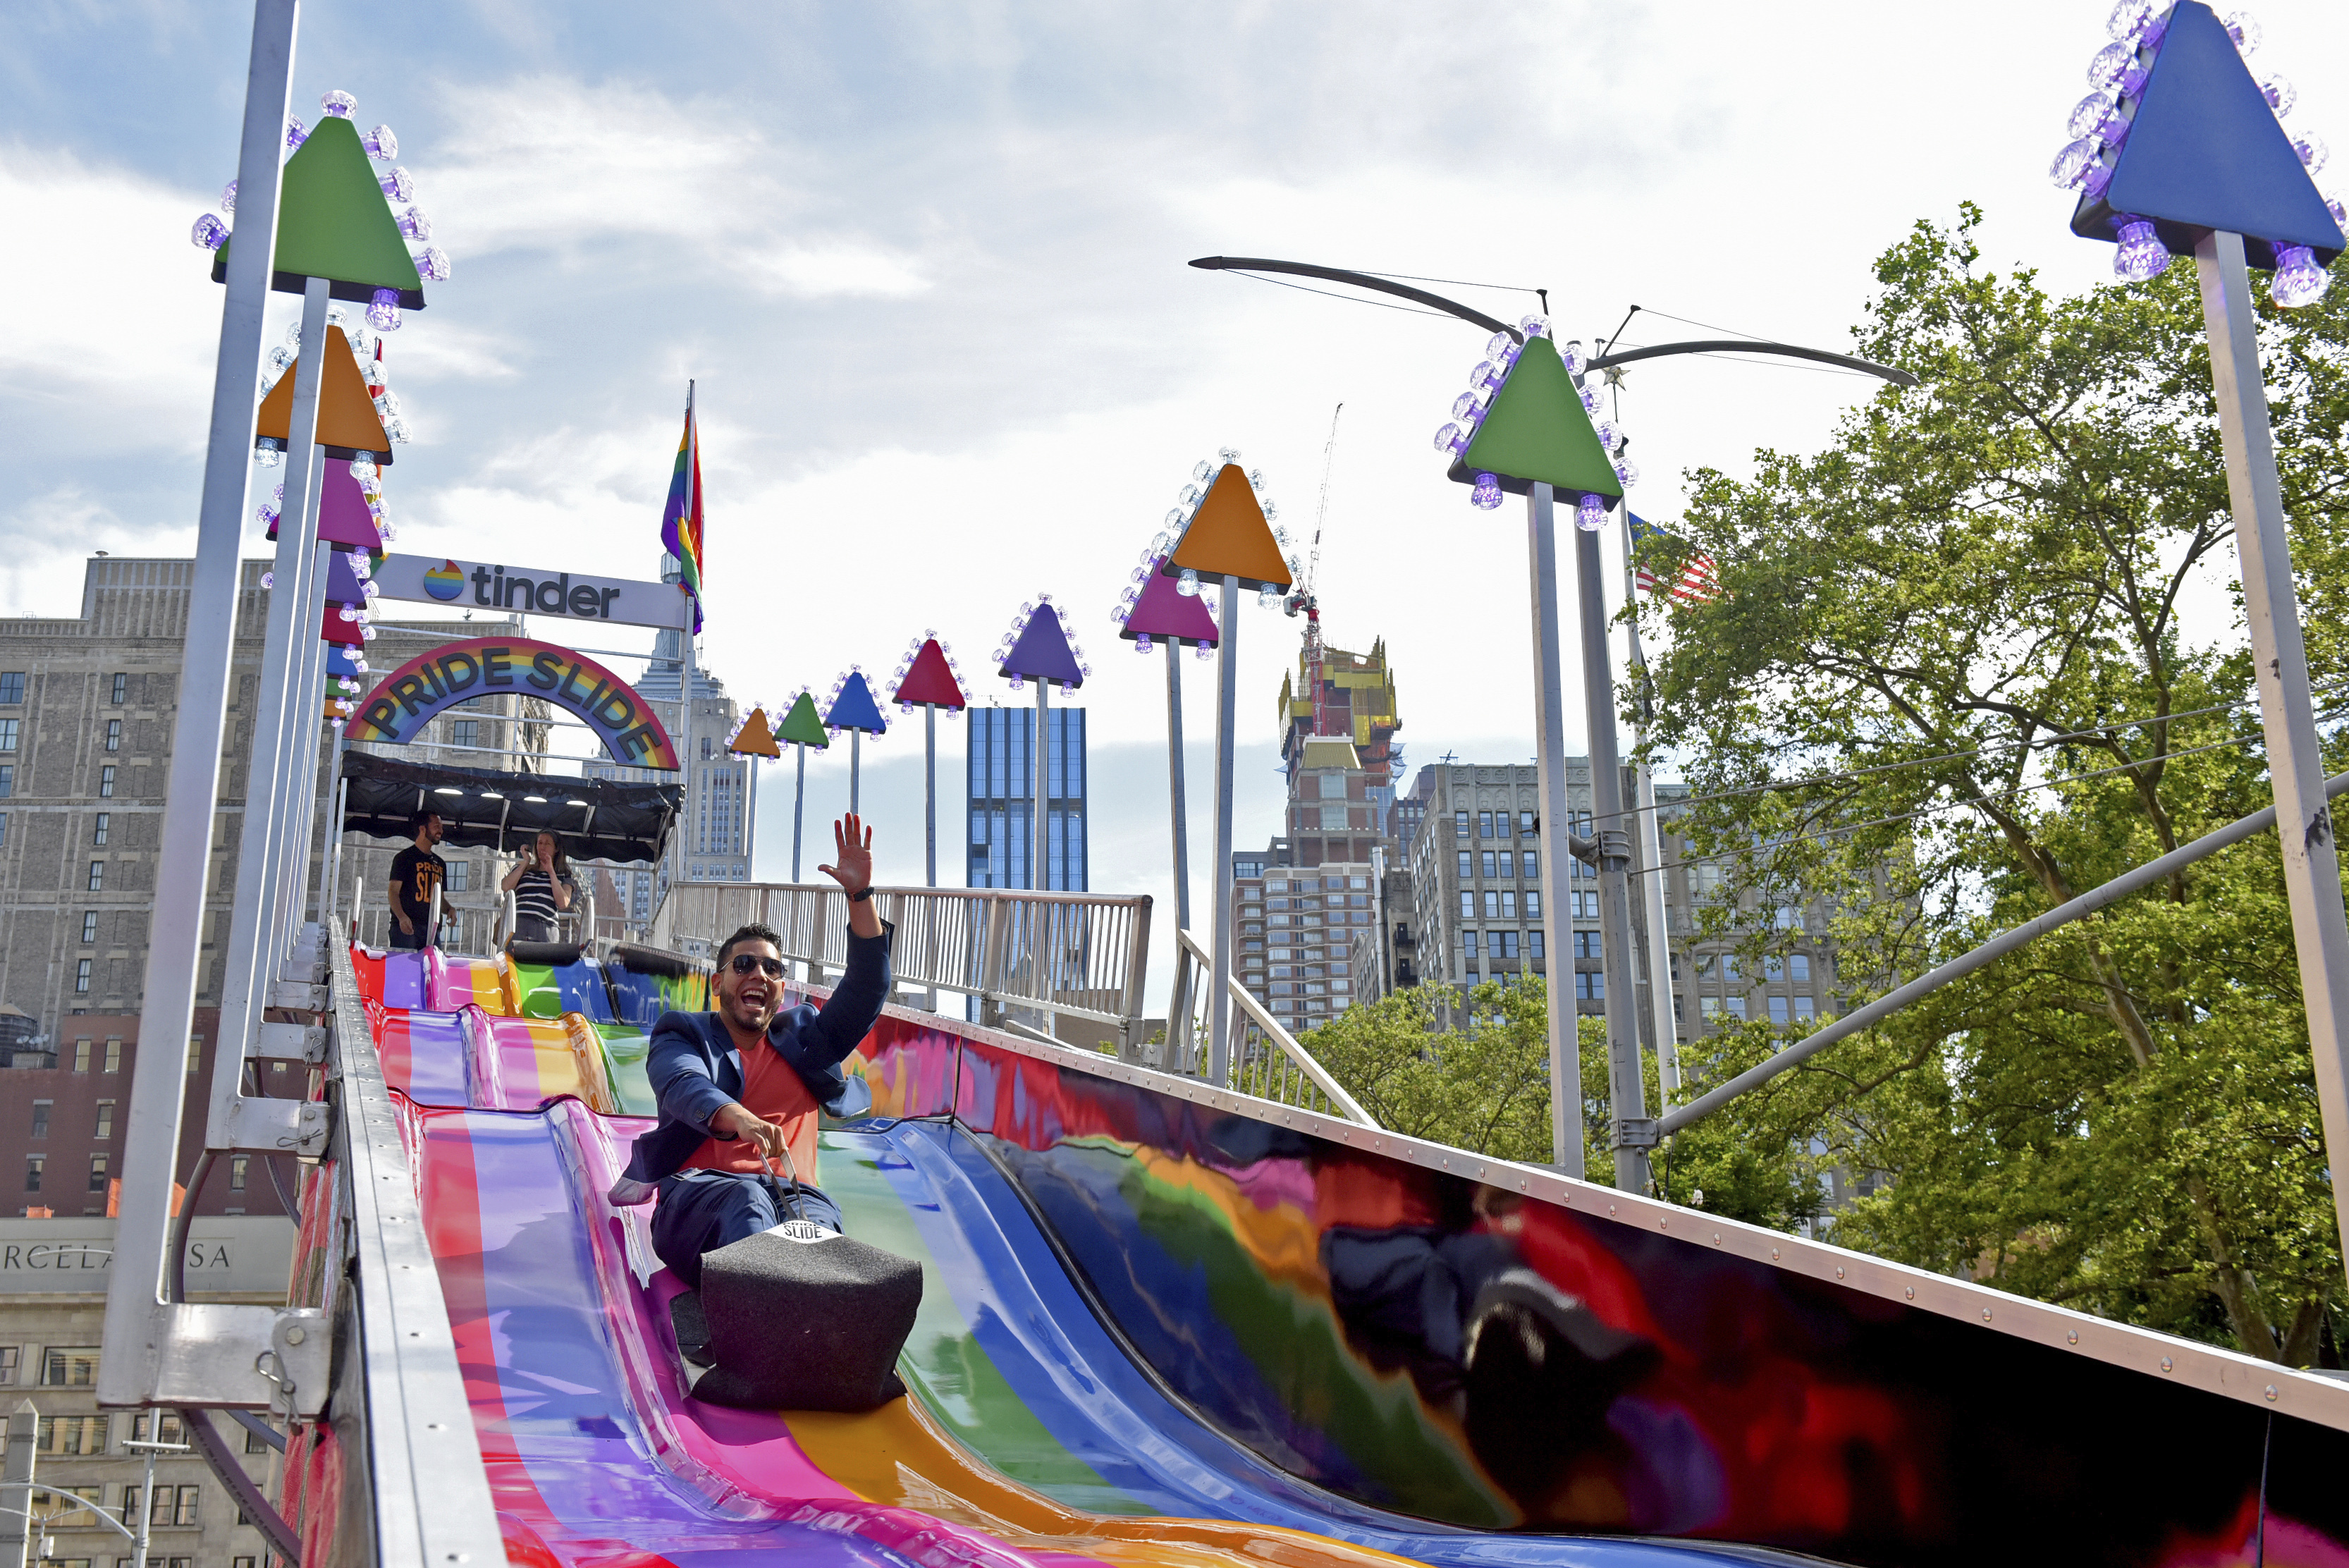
<box><xmin>350</xmin><ymin>637</ymin><xmax>677</xmax><ymax>771</ymax></box>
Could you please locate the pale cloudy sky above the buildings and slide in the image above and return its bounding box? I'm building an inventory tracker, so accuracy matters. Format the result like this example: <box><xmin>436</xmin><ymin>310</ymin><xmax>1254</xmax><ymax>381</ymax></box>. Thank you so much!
<box><xmin>0</xmin><ymin>0</ymin><xmax>2349</xmax><ymax>931</ymax></box>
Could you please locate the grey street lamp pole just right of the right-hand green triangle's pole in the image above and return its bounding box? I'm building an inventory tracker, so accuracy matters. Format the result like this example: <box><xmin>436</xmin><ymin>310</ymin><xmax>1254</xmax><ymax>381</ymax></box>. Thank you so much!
<box><xmin>1574</xmin><ymin>515</ymin><xmax>1649</xmax><ymax>1192</ymax></box>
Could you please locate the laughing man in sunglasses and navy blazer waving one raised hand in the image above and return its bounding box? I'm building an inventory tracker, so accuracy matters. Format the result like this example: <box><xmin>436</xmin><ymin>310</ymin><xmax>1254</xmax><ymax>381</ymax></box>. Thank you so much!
<box><xmin>611</xmin><ymin>814</ymin><xmax>890</xmax><ymax>1291</ymax></box>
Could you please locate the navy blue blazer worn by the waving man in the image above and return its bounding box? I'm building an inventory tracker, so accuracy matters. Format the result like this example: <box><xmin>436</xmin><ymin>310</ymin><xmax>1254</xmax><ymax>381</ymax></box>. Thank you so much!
<box><xmin>622</xmin><ymin>921</ymin><xmax>893</xmax><ymax>1196</ymax></box>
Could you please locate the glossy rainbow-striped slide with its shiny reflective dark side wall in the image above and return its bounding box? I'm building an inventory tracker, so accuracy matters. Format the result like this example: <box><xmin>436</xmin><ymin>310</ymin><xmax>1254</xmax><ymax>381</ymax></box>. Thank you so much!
<box><xmin>287</xmin><ymin>952</ymin><xmax>2349</xmax><ymax>1568</ymax></box>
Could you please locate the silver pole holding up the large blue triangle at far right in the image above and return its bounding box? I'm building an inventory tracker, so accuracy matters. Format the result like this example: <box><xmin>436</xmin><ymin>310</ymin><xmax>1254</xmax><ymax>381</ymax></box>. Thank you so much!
<box><xmin>2194</xmin><ymin>231</ymin><xmax>2349</xmax><ymax>1288</ymax></box>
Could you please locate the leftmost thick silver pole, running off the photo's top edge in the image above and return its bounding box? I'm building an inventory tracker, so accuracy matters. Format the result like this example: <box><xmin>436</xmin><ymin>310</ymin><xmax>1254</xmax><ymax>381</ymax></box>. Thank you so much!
<box><xmin>99</xmin><ymin>0</ymin><xmax>298</xmax><ymax>1410</ymax></box>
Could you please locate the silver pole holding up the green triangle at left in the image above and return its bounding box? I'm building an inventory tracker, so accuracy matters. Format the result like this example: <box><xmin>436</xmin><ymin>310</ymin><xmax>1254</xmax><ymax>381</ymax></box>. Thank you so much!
<box><xmin>204</xmin><ymin>276</ymin><xmax>329</xmax><ymax>1147</ymax></box>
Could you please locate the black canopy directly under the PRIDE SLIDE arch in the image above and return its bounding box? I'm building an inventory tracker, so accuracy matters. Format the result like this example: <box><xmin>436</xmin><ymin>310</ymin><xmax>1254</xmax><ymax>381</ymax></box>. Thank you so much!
<box><xmin>343</xmin><ymin>750</ymin><xmax>686</xmax><ymax>865</ymax></box>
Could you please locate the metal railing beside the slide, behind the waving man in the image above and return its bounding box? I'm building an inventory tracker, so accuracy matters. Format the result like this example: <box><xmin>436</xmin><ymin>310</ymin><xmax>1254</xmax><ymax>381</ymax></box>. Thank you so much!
<box><xmin>653</xmin><ymin>881</ymin><xmax>1151</xmax><ymax>1058</ymax></box>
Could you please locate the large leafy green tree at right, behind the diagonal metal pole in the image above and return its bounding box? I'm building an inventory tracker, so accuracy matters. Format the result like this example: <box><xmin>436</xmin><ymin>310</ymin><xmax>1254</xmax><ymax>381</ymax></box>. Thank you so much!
<box><xmin>1647</xmin><ymin>207</ymin><xmax>2349</xmax><ymax>1364</ymax></box>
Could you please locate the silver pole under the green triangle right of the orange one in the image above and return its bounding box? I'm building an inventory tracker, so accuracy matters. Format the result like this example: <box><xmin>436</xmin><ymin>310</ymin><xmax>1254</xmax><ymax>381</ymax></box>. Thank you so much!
<box><xmin>1524</xmin><ymin>484</ymin><xmax>1583</xmax><ymax>1180</ymax></box>
